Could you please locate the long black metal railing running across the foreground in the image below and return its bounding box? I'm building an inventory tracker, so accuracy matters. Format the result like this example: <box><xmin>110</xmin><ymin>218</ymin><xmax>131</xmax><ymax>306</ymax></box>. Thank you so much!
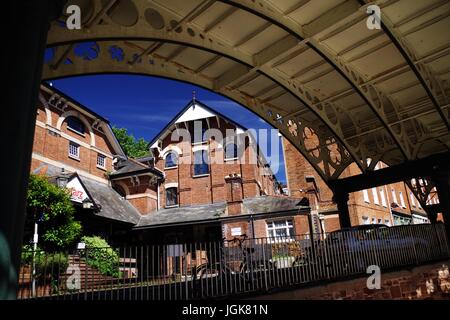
<box><xmin>18</xmin><ymin>223</ymin><xmax>450</xmax><ymax>300</ymax></box>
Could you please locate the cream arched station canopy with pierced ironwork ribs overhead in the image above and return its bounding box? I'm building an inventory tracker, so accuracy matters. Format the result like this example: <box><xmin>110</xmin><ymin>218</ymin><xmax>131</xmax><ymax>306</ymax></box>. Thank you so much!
<box><xmin>43</xmin><ymin>0</ymin><xmax>450</xmax><ymax>181</ymax></box>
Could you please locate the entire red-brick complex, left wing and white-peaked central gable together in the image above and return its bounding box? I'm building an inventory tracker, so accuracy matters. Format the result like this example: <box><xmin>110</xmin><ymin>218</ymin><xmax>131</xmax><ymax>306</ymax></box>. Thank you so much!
<box><xmin>30</xmin><ymin>84</ymin><xmax>309</xmax><ymax>245</ymax></box>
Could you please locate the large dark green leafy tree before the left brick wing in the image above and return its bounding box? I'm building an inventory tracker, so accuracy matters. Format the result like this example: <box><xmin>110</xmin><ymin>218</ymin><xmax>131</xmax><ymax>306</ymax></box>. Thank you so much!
<box><xmin>27</xmin><ymin>174</ymin><xmax>82</xmax><ymax>250</ymax></box>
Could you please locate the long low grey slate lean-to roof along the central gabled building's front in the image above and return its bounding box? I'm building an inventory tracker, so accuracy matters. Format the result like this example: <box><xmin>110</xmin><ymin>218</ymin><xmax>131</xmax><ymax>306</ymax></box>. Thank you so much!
<box><xmin>135</xmin><ymin>196</ymin><xmax>309</xmax><ymax>229</ymax></box>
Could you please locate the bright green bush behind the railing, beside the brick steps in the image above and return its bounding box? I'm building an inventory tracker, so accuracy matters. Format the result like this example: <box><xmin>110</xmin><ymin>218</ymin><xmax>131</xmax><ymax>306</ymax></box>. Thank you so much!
<box><xmin>81</xmin><ymin>236</ymin><xmax>120</xmax><ymax>277</ymax></box>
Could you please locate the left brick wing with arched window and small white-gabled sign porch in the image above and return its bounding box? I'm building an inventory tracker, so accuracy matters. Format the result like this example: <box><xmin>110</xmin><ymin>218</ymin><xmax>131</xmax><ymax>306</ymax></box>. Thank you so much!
<box><xmin>30</xmin><ymin>84</ymin><xmax>140</xmax><ymax>244</ymax></box>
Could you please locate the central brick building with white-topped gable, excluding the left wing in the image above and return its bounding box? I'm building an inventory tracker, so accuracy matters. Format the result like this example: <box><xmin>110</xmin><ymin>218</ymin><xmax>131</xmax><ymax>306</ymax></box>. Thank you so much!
<box><xmin>110</xmin><ymin>99</ymin><xmax>308</xmax><ymax>242</ymax></box>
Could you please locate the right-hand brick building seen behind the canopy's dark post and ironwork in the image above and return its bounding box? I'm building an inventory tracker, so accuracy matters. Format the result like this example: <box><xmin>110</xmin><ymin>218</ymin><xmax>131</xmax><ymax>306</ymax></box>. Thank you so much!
<box><xmin>283</xmin><ymin>139</ymin><xmax>438</xmax><ymax>232</ymax></box>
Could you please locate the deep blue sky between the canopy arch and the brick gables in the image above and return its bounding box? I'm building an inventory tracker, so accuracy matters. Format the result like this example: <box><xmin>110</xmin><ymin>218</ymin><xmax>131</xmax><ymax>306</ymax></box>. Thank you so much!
<box><xmin>51</xmin><ymin>75</ymin><xmax>286</xmax><ymax>182</ymax></box>
